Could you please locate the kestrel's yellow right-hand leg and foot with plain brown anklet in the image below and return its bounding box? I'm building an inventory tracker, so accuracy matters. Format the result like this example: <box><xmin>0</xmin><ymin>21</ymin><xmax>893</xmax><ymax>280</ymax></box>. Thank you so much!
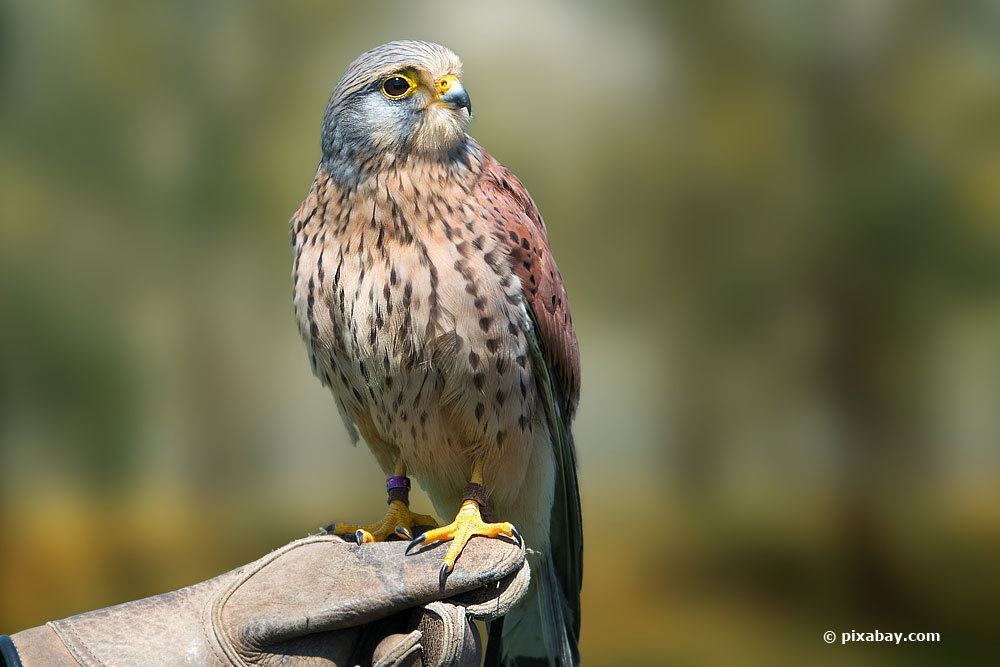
<box><xmin>406</xmin><ymin>460</ymin><xmax>523</xmax><ymax>586</ymax></box>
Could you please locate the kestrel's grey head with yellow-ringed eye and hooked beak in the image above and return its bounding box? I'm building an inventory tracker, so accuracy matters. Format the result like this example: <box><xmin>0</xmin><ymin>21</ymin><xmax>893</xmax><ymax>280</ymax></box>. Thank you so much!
<box><xmin>322</xmin><ymin>40</ymin><xmax>472</xmax><ymax>172</ymax></box>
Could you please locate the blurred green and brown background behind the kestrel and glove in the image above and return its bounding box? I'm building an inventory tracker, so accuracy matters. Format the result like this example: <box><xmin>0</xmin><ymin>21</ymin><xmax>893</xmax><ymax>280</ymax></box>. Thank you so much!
<box><xmin>0</xmin><ymin>0</ymin><xmax>1000</xmax><ymax>665</ymax></box>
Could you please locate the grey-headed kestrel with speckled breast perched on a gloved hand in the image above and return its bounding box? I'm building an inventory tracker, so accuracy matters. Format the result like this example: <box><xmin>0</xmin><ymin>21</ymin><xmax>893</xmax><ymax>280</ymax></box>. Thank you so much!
<box><xmin>291</xmin><ymin>40</ymin><xmax>583</xmax><ymax>664</ymax></box>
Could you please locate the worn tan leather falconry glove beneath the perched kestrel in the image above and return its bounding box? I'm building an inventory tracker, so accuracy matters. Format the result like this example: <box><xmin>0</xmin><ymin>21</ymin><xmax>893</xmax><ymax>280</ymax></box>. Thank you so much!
<box><xmin>0</xmin><ymin>535</ymin><xmax>529</xmax><ymax>667</ymax></box>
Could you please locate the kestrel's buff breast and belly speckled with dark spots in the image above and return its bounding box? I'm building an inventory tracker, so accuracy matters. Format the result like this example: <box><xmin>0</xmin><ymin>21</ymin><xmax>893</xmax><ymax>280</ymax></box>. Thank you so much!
<box><xmin>292</xmin><ymin>163</ymin><xmax>535</xmax><ymax>486</ymax></box>
